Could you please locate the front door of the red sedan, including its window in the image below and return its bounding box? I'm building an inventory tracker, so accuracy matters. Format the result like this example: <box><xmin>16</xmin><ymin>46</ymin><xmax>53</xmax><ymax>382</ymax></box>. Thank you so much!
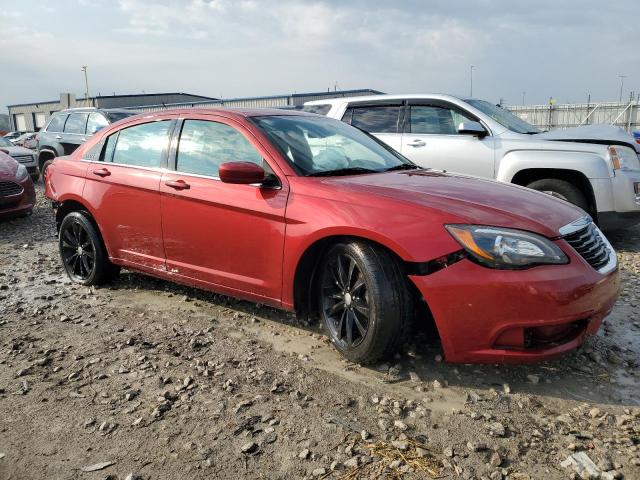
<box><xmin>160</xmin><ymin>114</ymin><xmax>288</xmax><ymax>304</ymax></box>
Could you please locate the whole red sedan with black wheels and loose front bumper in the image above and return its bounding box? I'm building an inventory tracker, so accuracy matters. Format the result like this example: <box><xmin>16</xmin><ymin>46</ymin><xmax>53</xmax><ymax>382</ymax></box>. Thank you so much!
<box><xmin>41</xmin><ymin>109</ymin><xmax>619</xmax><ymax>362</ymax></box>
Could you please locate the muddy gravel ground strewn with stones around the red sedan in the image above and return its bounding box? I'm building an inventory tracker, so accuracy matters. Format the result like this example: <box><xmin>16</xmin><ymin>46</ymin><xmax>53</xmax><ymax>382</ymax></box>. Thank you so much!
<box><xmin>0</xmin><ymin>187</ymin><xmax>640</xmax><ymax>480</ymax></box>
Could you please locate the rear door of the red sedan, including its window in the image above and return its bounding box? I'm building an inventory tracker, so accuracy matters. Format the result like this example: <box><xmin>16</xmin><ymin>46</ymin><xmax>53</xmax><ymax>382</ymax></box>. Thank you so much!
<box><xmin>84</xmin><ymin>118</ymin><xmax>174</xmax><ymax>270</ymax></box>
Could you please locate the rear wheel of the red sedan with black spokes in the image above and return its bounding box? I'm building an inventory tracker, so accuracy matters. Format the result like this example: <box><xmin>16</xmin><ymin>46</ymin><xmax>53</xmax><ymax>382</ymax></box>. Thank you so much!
<box><xmin>58</xmin><ymin>212</ymin><xmax>119</xmax><ymax>285</ymax></box>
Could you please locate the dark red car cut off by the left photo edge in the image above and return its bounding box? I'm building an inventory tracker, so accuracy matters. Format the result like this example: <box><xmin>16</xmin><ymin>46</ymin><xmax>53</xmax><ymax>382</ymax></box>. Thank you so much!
<box><xmin>0</xmin><ymin>149</ymin><xmax>36</xmax><ymax>219</ymax></box>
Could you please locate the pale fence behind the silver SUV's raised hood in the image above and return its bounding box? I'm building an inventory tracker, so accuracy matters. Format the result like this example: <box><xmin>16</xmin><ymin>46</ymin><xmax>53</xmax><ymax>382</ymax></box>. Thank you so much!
<box><xmin>505</xmin><ymin>99</ymin><xmax>640</xmax><ymax>132</ymax></box>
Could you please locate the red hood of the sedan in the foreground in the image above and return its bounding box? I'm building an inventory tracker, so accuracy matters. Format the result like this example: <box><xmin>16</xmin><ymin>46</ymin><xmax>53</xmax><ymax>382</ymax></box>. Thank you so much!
<box><xmin>324</xmin><ymin>170</ymin><xmax>585</xmax><ymax>238</ymax></box>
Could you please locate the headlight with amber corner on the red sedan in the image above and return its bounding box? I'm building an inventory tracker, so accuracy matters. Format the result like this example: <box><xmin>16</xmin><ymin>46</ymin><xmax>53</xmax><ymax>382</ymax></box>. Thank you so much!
<box><xmin>445</xmin><ymin>225</ymin><xmax>569</xmax><ymax>269</ymax></box>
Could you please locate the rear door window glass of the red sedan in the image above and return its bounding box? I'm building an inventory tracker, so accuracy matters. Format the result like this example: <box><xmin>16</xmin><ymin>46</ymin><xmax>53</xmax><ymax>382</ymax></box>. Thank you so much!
<box><xmin>110</xmin><ymin>120</ymin><xmax>171</xmax><ymax>168</ymax></box>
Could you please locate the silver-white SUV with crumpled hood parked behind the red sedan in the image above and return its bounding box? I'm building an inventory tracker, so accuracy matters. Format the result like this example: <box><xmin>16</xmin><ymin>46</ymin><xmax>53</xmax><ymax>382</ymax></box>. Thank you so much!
<box><xmin>303</xmin><ymin>95</ymin><xmax>640</xmax><ymax>230</ymax></box>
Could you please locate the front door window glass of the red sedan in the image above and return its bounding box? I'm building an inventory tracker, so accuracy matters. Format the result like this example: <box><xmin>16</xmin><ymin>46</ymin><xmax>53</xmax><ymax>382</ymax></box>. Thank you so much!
<box><xmin>176</xmin><ymin>120</ymin><xmax>263</xmax><ymax>177</ymax></box>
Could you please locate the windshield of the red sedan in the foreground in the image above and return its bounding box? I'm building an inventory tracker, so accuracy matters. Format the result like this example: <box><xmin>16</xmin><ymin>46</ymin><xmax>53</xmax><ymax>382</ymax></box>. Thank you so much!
<box><xmin>254</xmin><ymin>116</ymin><xmax>417</xmax><ymax>176</ymax></box>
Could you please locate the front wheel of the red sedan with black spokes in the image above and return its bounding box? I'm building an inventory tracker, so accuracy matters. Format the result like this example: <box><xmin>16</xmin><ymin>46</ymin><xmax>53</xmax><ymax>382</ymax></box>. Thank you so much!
<box><xmin>317</xmin><ymin>241</ymin><xmax>415</xmax><ymax>364</ymax></box>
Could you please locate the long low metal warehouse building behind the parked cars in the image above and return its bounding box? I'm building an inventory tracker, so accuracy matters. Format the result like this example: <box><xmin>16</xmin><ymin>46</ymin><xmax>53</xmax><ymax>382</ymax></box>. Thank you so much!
<box><xmin>7</xmin><ymin>89</ymin><xmax>382</xmax><ymax>132</ymax></box>
